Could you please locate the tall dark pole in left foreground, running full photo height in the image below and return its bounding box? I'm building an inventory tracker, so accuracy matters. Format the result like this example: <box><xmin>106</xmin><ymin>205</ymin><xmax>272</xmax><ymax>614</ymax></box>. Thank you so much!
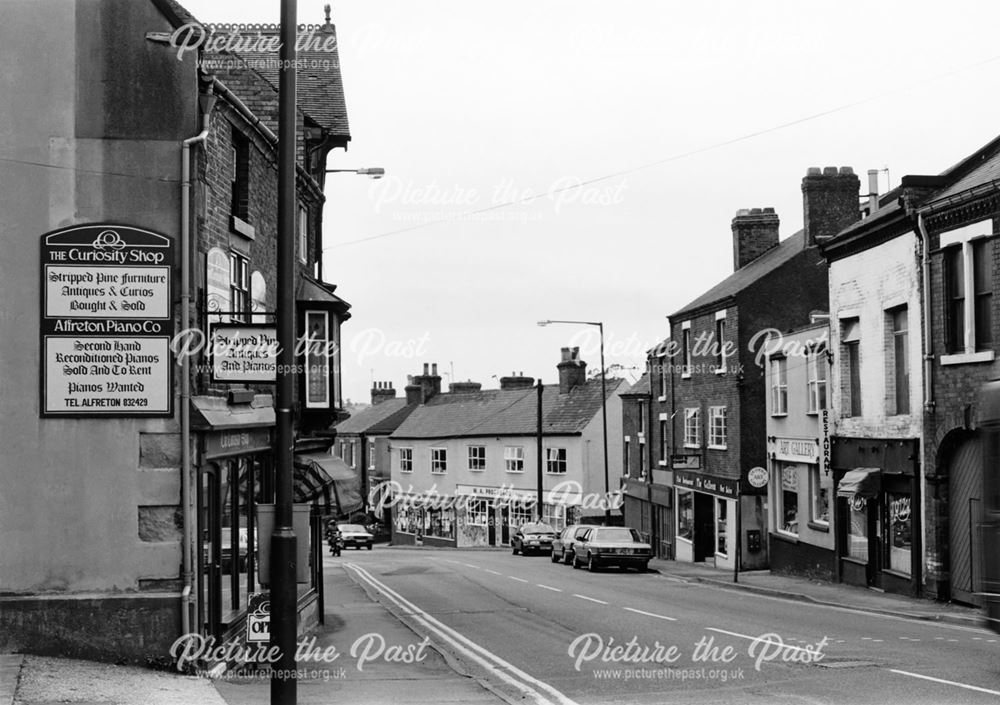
<box><xmin>270</xmin><ymin>0</ymin><xmax>296</xmax><ymax>705</ymax></box>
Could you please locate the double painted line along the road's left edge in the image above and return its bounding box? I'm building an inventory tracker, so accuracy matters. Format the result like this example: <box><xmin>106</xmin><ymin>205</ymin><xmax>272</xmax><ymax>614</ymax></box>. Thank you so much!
<box><xmin>346</xmin><ymin>563</ymin><xmax>577</xmax><ymax>705</ymax></box>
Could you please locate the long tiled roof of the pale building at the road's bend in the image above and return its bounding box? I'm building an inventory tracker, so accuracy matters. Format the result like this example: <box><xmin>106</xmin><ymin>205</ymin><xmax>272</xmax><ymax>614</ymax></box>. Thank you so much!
<box><xmin>392</xmin><ymin>379</ymin><xmax>623</xmax><ymax>438</ymax></box>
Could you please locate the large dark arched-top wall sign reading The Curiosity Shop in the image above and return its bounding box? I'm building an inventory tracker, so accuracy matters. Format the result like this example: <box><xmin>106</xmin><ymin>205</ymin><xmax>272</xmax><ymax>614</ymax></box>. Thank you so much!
<box><xmin>41</xmin><ymin>224</ymin><xmax>174</xmax><ymax>416</ymax></box>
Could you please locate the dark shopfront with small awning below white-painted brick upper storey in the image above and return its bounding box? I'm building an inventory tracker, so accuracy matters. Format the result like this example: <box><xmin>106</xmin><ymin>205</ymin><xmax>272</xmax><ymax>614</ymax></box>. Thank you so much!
<box><xmin>831</xmin><ymin>436</ymin><xmax>923</xmax><ymax>595</ymax></box>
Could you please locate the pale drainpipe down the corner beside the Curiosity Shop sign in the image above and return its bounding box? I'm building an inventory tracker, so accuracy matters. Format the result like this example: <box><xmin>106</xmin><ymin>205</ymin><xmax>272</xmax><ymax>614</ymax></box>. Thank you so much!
<box><xmin>180</xmin><ymin>94</ymin><xmax>215</xmax><ymax>634</ymax></box>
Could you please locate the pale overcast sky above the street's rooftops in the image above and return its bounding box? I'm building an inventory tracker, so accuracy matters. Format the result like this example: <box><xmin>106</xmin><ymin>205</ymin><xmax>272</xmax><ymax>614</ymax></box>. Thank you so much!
<box><xmin>182</xmin><ymin>0</ymin><xmax>1000</xmax><ymax>402</ymax></box>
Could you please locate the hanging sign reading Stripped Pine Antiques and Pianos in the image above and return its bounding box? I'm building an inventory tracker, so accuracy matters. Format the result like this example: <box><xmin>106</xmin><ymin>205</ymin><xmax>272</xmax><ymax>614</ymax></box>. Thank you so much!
<box><xmin>209</xmin><ymin>323</ymin><xmax>278</xmax><ymax>384</ymax></box>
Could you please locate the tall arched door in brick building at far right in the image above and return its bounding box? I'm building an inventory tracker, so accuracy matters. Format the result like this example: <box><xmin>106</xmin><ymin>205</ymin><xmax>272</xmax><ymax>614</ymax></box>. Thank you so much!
<box><xmin>948</xmin><ymin>438</ymin><xmax>982</xmax><ymax>605</ymax></box>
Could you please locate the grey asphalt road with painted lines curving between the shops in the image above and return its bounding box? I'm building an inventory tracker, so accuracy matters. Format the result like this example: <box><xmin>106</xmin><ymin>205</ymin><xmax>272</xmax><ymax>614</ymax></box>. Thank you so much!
<box><xmin>334</xmin><ymin>548</ymin><xmax>1000</xmax><ymax>705</ymax></box>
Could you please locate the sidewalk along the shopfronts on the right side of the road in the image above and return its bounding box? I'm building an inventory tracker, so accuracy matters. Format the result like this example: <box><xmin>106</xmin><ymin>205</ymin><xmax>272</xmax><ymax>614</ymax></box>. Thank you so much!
<box><xmin>649</xmin><ymin>559</ymin><xmax>982</xmax><ymax>627</ymax></box>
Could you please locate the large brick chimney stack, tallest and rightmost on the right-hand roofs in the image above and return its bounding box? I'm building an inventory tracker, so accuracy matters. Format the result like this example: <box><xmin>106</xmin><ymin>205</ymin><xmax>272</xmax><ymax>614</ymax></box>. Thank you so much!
<box><xmin>802</xmin><ymin>166</ymin><xmax>861</xmax><ymax>247</ymax></box>
